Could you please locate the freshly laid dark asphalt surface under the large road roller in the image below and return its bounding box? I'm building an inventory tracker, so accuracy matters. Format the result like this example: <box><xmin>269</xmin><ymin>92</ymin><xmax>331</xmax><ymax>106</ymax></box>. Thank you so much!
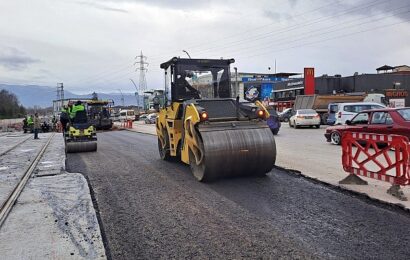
<box><xmin>67</xmin><ymin>131</ymin><xmax>410</xmax><ymax>259</ymax></box>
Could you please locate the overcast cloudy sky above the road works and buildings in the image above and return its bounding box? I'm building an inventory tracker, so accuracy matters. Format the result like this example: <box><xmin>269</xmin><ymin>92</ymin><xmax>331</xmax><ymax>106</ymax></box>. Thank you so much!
<box><xmin>0</xmin><ymin>0</ymin><xmax>410</xmax><ymax>93</ymax></box>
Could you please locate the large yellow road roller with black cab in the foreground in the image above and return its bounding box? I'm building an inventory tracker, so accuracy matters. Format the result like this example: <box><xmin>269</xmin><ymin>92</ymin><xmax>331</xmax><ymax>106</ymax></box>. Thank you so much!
<box><xmin>156</xmin><ymin>57</ymin><xmax>276</xmax><ymax>182</ymax></box>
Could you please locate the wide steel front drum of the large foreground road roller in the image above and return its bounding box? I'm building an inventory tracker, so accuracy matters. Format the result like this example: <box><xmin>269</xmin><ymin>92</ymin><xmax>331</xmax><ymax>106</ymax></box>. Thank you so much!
<box><xmin>190</xmin><ymin>124</ymin><xmax>276</xmax><ymax>181</ymax></box>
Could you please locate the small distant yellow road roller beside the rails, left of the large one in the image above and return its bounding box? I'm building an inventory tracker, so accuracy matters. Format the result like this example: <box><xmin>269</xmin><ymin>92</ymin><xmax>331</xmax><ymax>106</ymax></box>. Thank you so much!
<box><xmin>64</xmin><ymin>105</ymin><xmax>97</xmax><ymax>153</ymax></box>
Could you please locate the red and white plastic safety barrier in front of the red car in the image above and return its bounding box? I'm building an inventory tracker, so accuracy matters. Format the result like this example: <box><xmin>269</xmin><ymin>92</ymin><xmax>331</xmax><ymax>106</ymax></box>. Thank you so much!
<box><xmin>339</xmin><ymin>132</ymin><xmax>410</xmax><ymax>200</ymax></box>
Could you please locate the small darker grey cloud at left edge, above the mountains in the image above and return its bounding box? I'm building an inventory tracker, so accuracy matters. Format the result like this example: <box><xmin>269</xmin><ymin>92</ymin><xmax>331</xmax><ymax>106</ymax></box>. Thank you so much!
<box><xmin>0</xmin><ymin>47</ymin><xmax>40</xmax><ymax>70</ymax></box>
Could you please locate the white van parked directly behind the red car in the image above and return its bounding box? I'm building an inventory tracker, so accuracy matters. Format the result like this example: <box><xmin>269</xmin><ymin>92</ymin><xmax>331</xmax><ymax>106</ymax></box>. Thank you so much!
<box><xmin>335</xmin><ymin>102</ymin><xmax>385</xmax><ymax>125</ymax></box>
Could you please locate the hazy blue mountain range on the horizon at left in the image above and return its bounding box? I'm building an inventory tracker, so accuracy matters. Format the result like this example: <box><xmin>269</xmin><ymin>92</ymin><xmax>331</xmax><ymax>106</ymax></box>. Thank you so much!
<box><xmin>0</xmin><ymin>84</ymin><xmax>143</xmax><ymax>108</ymax></box>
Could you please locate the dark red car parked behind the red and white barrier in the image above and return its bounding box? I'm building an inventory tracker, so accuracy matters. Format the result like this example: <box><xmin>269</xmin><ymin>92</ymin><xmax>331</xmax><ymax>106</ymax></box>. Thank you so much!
<box><xmin>325</xmin><ymin>107</ymin><xmax>410</xmax><ymax>144</ymax></box>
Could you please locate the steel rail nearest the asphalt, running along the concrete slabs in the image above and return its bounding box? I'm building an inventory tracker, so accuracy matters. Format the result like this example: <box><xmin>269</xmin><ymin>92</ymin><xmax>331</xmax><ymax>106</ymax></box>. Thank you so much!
<box><xmin>0</xmin><ymin>133</ymin><xmax>55</xmax><ymax>228</ymax></box>
